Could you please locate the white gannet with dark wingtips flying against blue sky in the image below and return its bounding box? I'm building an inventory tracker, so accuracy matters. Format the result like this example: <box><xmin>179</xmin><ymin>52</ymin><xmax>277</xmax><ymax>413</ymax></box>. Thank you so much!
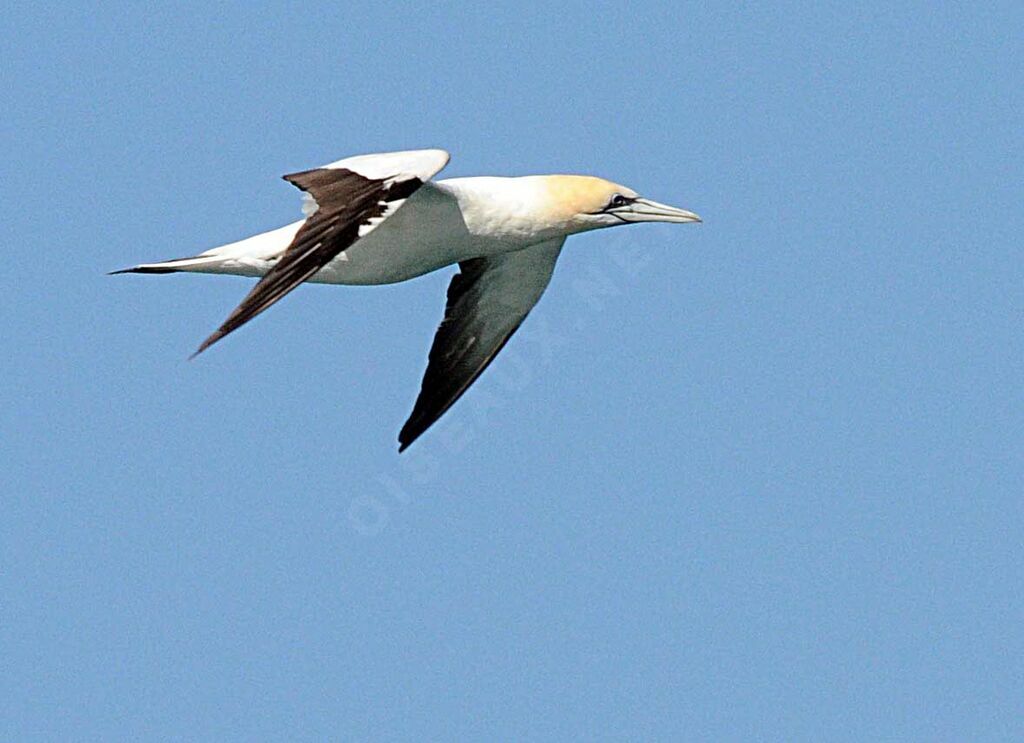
<box><xmin>113</xmin><ymin>149</ymin><xmax>700</xmax><ymax>451</ymax></box>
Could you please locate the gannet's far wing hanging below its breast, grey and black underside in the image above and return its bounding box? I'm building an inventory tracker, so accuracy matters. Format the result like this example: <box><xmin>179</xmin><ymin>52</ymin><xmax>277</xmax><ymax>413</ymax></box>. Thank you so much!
<box><xmin>398</xmin><ymin>237</ymin><xmax>565</xmax><ymax>451</ymax></box>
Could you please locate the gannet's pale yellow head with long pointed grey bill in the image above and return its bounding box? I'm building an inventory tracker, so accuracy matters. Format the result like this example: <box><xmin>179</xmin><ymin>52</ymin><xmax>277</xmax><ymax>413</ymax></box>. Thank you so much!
<box><xmin>545</xmin><ymin>175</ymin><xmax>700</xmax><ymax>232</ymax></box>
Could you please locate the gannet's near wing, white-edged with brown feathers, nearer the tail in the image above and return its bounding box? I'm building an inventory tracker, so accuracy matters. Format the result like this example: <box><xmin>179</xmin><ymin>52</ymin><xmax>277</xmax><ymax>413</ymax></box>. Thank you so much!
<box><xmin>194</xmin><ymin>149</ymin><xmax>449</xmax><ymax>355</ymax></box>
